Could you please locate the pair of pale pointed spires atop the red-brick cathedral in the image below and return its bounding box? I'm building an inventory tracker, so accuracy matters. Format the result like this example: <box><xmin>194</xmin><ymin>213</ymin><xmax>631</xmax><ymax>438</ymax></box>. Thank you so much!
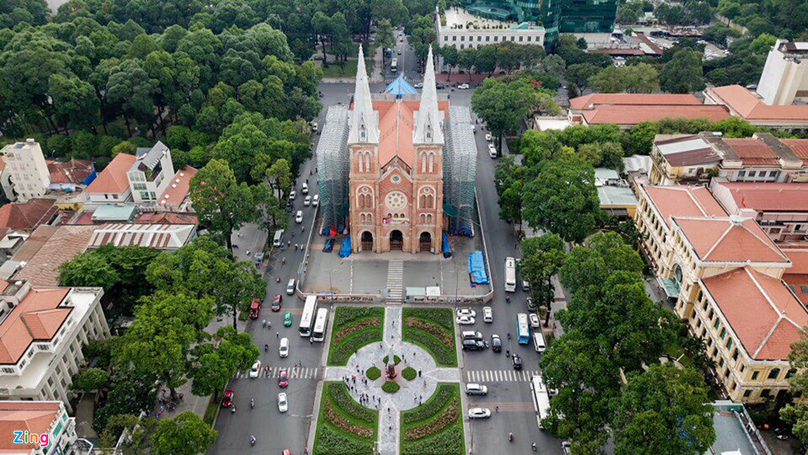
<box><xmin>348</xmin><ymin>45</ymin><xmax>444</xmax><ymax>145</ymax></box>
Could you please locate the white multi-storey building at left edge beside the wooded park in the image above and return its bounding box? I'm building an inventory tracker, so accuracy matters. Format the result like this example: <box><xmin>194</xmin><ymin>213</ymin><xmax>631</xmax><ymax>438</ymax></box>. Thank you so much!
<box><xmin>1</xmin><ymin>139</ymin><xmax>50</xmax><ymax>202</ymax></box>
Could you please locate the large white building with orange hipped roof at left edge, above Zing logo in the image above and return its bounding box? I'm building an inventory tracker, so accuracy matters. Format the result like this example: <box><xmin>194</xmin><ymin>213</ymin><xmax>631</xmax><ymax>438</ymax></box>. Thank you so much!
<box><xmin>0</xmin><ymin>281</ymin><xmax>109</xmax><ymax>411</ymax></box>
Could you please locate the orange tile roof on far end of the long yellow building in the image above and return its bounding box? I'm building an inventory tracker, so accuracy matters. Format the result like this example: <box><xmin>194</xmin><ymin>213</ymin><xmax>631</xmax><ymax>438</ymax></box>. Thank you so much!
<box><xmin>641</xmin><ymin>186</ymin><xmax>727</xmax><ymax>227</ymax></box>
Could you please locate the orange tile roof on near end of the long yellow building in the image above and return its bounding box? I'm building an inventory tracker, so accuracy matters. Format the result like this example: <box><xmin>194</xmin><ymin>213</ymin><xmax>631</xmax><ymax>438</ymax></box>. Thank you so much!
<box><xmin>701</xmin><ymin>267</ymin><xmax>808</xmax><ymax>360</ymax></box>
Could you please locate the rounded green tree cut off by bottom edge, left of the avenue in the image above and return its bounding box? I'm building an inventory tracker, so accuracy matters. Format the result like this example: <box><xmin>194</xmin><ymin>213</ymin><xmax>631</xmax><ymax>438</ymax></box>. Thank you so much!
<box><xmin>152</xmin><ymin>411</ymin><xmax>219</xmax><ymax>455</ymax></box>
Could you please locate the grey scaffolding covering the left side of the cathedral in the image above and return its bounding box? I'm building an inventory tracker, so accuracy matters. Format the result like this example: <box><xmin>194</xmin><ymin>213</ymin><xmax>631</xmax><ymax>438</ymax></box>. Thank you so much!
<box><xmin>317</xmin><ymin>106</ymin><xmax>350</xmax><ymax>236</ymax></box>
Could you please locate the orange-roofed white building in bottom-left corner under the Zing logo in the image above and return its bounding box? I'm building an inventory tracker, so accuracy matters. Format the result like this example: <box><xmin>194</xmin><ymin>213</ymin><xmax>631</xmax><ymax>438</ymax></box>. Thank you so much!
<box><xmin>0</xmin><ymin>401</ymin><xmax>76</xmax><ymax>455</ymax></box>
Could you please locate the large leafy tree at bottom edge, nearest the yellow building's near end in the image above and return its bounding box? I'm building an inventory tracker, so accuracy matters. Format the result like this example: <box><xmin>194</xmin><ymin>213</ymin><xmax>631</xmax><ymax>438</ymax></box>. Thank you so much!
<box><xmin>612</xmin><ymin>363</ymin><xmax>716</xmax><ymax>455</ymax></box>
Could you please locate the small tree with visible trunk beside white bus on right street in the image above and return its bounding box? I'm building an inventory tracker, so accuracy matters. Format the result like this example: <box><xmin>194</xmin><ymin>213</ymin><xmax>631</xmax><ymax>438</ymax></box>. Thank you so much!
<box><xmin>519</xmin><ymin>234</ymin><xmax>566</xmax><ymax>327</ymax></box>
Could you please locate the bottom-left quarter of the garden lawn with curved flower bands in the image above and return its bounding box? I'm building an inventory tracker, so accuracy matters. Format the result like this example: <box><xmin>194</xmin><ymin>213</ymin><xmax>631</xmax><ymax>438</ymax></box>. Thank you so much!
<box><xmin>314</xmin><ymin>381</ymin><xmax>379</xmax><ymax>455</ymax></box>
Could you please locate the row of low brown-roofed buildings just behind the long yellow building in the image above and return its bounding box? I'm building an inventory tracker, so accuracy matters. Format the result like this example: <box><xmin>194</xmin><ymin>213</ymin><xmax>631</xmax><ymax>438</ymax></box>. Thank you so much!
<box><xmin>648</xmin><ymin>132</ymin><xmax>808</xmax><ymax>185</ymax></box>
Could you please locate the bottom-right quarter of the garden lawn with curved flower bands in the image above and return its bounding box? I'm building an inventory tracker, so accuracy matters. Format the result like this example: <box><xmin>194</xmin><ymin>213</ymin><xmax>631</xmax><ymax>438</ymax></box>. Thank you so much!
<box><xmin>401</xmin><ymin>383</ymin><xmax>466</xmax><ymax>455</ymax></box>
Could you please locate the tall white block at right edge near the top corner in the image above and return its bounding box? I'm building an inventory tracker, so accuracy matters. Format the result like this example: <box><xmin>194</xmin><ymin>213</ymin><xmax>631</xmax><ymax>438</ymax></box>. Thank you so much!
<box><xmin>757</xmin><ymin>40</ymin><xmax>808</xmax><ymax>106</ymax></box>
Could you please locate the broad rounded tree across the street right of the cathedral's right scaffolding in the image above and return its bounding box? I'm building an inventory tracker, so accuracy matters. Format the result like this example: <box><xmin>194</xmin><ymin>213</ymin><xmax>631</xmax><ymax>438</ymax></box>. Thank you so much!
<box><xmin>523</xmin><ymin>159</ymin><xmax>600</xmax><ymax>242</ymax></box>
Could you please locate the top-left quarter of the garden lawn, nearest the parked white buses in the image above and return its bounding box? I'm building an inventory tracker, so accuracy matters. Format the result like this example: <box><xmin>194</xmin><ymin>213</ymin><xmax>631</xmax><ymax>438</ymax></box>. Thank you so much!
<box><xmin>328</xmin><ymin>306</ymin><xmax>384</xmax><ymax>366</ymax></box>
